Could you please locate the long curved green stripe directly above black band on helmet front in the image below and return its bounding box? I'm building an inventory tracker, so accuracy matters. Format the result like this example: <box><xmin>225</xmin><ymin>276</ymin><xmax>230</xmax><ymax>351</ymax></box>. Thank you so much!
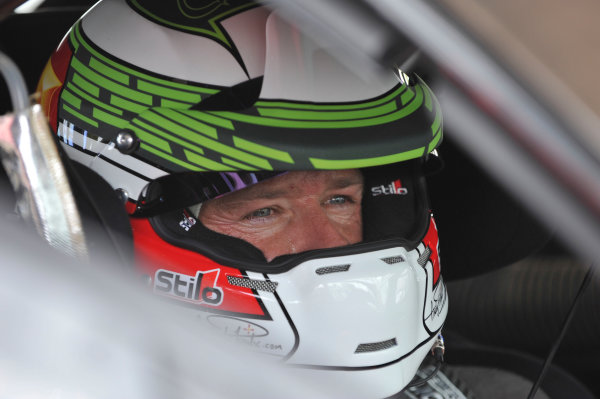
<box><xmin>215</xmin><ymin>86</ymin><xmax>423</xmax><ymax>129</ymax></box>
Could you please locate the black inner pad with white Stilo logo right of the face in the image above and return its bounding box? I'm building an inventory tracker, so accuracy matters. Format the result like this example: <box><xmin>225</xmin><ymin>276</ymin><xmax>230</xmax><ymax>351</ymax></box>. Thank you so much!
<box><xmin>362</xmin><ymin>160</ymin><xmax>430</xmax><ymax>242</ymax></box>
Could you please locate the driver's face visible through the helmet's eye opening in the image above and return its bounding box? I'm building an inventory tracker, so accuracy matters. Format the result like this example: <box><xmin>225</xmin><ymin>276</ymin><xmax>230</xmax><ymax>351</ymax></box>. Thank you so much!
<box><xmin>199</xmin><ymin>170</ymin><xmax>363</xmax><ymax>261</ymax></box>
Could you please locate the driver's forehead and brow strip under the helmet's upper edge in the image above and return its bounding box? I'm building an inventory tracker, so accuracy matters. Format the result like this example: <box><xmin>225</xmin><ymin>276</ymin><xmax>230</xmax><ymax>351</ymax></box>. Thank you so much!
<box><xmin>219</xmin><ymin>169</ymin><xmax>363</xmax><ymax>201</ymax></box>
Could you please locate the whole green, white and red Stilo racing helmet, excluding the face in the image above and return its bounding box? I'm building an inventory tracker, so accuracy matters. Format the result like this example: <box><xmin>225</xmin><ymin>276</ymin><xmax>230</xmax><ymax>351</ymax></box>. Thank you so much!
<box><xmin>38</xmin><ymin>0</ymin><xmax>448</xmax><ymax>397</ymax></box>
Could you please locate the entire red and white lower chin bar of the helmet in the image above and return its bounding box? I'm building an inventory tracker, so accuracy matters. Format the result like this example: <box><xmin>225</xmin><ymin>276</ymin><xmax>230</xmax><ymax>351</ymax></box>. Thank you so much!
<box><xmin>136</xmin><ymin>219</ymin><xmax>448</xmax><ymax>397</ymax></box>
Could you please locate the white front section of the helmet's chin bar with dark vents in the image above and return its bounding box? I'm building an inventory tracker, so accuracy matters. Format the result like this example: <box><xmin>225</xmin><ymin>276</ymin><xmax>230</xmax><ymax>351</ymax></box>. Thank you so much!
<box><xmin>267</xmin><ymin>238</ymin><xmax>447</xmax><ymax>397</ymax></box>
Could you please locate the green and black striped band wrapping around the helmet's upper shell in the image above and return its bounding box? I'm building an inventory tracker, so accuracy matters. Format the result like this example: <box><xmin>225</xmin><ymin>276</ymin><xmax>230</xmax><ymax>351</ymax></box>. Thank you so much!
<box><xmin>59</xmin><ymin>19</ymin><xmax>442</xmax><ymax>172</ymax></box>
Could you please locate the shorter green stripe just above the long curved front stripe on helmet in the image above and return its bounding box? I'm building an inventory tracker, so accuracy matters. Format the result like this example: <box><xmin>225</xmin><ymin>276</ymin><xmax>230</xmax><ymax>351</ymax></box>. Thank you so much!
<box><xmin>258</xmin><ymin>101</ymin><xmax>397</xmax><ymax>121</ymax></box>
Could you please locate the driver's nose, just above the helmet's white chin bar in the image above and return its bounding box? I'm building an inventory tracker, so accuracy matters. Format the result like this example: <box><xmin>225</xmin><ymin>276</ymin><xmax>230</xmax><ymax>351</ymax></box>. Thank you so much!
<box><xmin>288</xmin><ymin>209</ymin><xmax>362</xmax><ymax>253</ymax></box>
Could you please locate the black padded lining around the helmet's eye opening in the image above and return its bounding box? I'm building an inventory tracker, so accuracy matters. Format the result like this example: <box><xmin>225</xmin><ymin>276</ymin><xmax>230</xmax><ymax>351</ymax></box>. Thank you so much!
<box><xmin>139</xmin><ymin>160</ymin><xmax>429</xmax><ymax>272</ymax></box>
